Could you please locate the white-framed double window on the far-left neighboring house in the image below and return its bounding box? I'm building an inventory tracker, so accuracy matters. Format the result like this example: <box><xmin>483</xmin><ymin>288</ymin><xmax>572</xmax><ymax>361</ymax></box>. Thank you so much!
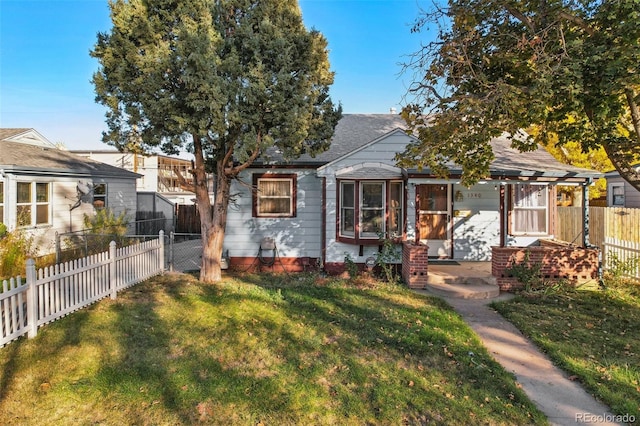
<box><xmin>16</xmin><ymin>182</ymin><xmax>50</xmax><ymax>226</ymax></box>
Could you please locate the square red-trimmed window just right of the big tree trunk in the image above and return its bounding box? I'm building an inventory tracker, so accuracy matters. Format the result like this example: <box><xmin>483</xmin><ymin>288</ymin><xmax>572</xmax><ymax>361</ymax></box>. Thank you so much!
<box><xmin>253</xmin><ymin>174</ymin><xmax>296</xmax><ymax>217</ymax></box>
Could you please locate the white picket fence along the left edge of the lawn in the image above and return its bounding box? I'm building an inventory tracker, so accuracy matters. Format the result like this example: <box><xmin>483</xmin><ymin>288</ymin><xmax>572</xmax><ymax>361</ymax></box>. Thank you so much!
<box><xmin>0</xmin><ymin>231</ymin><xmax>164</xmax><ymax>347</ymax></box>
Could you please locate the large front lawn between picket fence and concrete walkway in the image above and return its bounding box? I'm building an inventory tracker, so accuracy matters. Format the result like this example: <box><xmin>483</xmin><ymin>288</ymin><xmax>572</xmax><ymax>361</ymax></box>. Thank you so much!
<box><xmin>0</xmin><ymin>275</ymin><xmax>546</xmax><ymax>425</ymax></box>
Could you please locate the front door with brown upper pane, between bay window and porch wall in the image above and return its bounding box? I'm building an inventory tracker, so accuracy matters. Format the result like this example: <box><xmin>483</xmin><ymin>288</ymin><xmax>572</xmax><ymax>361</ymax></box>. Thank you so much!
<box><xmin>416</xmin><ymin>184</ymin><xmax>451</xmax><ymax>259</ymax></box>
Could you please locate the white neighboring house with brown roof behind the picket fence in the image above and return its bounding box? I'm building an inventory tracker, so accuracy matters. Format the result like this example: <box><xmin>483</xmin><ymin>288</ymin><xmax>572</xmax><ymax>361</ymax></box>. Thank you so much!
<box><xmin>0</xmin><ymin>128</ymin><xmax>139</xmax><ymax>253</ymax></box>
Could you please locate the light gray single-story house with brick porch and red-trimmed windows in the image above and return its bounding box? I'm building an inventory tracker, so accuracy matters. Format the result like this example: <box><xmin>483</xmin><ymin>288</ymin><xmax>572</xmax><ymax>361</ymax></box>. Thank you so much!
<box><xmin>224</xmin><ymin>114</ymin><xmax>600</xmax><ymax>272</ymax></box>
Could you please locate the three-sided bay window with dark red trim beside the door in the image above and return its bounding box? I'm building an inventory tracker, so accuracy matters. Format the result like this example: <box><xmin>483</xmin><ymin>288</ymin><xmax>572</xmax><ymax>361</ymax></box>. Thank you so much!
<box><xmin>338</xmin><ymin>180</ymin><xmax>404</xmax><ymax>243</ymax></box>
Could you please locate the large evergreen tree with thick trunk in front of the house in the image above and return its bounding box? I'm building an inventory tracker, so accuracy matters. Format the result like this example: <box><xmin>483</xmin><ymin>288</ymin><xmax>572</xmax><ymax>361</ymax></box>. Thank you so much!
<box><xmin>91</xmin><ymin>0</ymin><xmax>341</xmax><ymax>282</ymax></box>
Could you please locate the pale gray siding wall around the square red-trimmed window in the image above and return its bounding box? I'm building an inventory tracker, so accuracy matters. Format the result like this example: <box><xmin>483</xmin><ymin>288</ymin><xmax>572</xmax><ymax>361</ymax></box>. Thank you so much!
<box><xmin>224</xmin><ymin>169</ymin><xmax>322</xmax><ymax>258</ymax></box>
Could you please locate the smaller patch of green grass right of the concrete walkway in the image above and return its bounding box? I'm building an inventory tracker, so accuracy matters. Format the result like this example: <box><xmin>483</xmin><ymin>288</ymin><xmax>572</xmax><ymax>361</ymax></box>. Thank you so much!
<box><xmin>493</xmin><ymin>281</ymin><xmax>640</xmax><ymax>420</ymax></box>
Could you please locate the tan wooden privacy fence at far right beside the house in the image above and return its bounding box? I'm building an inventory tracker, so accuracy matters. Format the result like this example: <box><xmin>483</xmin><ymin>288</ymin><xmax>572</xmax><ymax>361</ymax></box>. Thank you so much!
<box><xmin>556</xmin><ymin>206</ymin><xmax>640</xmax><ymax>279</ymax></box>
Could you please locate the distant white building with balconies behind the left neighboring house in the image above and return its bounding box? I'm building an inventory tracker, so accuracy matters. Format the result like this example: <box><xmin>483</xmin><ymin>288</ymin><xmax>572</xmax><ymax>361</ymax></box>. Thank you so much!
<box><xmin>72</xmin><ymin>150</ymin><xmax>200</xmax><ymax>204</ymax></box>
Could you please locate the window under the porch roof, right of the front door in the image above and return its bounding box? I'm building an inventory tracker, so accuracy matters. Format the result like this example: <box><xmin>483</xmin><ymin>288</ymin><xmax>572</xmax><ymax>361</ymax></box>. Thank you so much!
<box><xmin>511</xmin><ymin>184</ymin><xmax>549</xmax><ymax>235</ymax></box>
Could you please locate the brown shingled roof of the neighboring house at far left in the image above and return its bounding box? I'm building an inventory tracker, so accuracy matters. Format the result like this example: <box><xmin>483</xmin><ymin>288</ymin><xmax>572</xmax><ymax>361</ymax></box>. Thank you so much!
<box><xmin>0</xmin><ymin>129</ymin><xmax>140</xmax><ymax>179</ymax></box>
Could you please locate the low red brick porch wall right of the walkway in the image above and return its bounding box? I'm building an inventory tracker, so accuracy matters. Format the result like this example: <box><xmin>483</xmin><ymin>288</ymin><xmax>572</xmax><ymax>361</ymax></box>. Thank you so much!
<box><xmin>491</xmin><ymin>242</ymin><xmax>598</xmax><ymax>291</ymax></box>
